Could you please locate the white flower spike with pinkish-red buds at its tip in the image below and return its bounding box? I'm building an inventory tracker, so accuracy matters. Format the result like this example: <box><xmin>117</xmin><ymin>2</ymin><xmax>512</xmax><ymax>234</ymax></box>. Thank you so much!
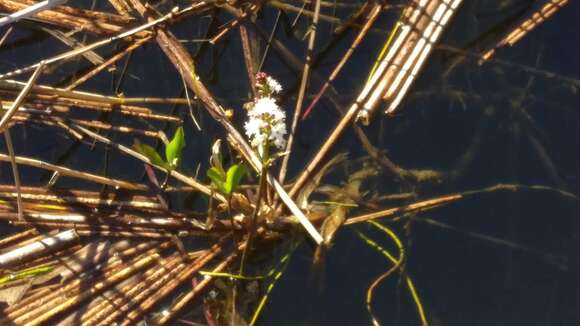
<box><xmin>244</xmin><ymin>72</ymin><xmax>286</xmax><ymax>156</ymax></box>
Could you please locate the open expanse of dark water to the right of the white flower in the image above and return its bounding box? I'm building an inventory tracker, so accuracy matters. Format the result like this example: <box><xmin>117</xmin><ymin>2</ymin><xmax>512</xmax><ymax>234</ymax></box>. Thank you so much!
<box><xmin>264</xmin><ymin>1</ymin><xmax>580</xmax><ymax>325</ymax></box>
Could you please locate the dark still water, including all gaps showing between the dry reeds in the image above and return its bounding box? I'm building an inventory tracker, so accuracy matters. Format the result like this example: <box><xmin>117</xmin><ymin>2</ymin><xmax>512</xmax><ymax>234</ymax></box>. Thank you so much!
<box><xmin>0</xmin><ymin>1</ymin><xmax>580</xmax><ymax>325</ymax></box>
